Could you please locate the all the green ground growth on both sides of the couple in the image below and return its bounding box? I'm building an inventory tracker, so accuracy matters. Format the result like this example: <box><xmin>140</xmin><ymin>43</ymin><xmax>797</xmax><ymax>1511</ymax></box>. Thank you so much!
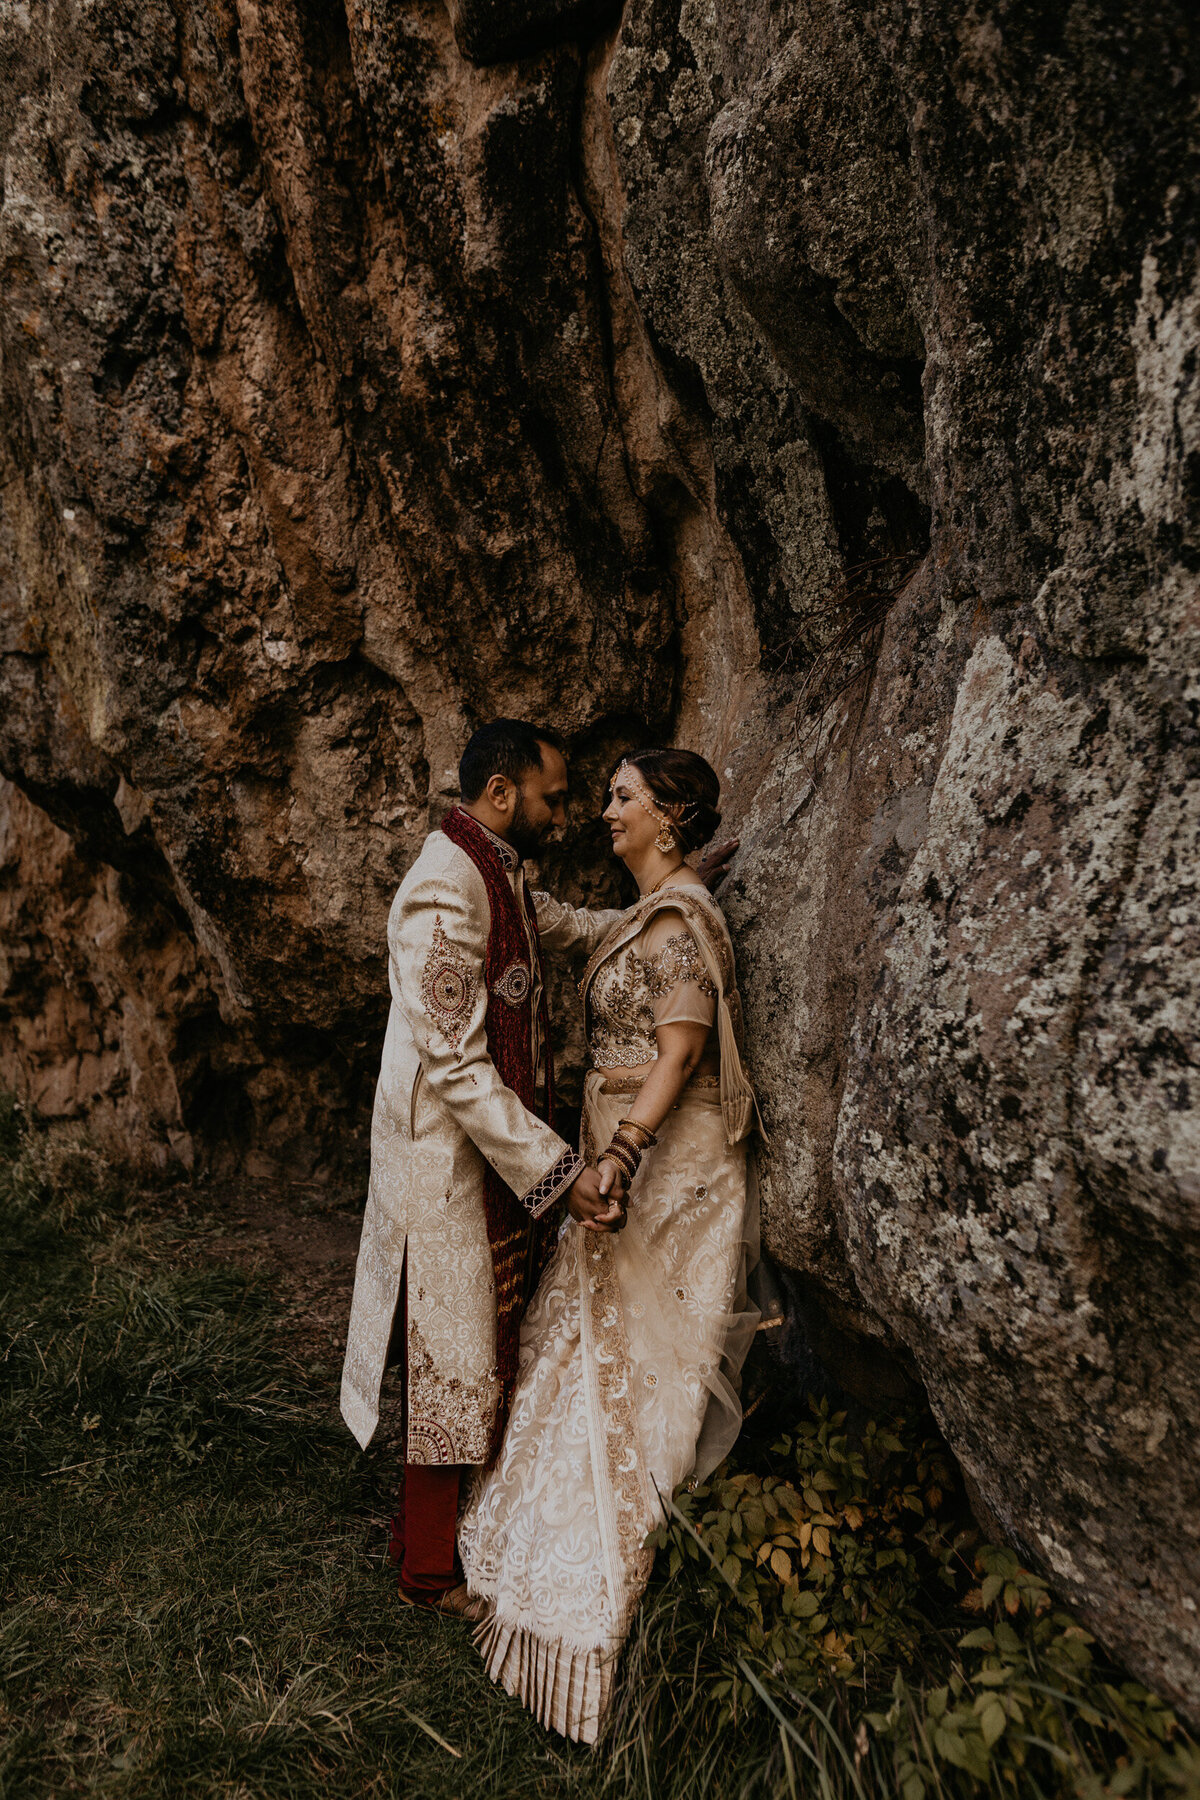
<box><xmin>0</xmin><ymin>1109</ymin><xmax>1200</xmax><ymax>1800</ymax></box>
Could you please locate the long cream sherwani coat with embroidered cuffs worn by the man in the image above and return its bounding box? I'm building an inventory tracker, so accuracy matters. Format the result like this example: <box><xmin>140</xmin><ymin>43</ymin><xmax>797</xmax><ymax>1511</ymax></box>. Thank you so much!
<box><xmin>342</xmin><ymin>830</ymin><xmax>621</xmax><ymax>1463</ymax></box>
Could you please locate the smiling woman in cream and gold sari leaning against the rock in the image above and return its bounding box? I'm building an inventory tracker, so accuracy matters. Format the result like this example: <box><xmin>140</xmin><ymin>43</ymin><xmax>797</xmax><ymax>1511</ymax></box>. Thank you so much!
<box><xmin>459</xmin><ymin>751</ymin><xmax>757</xmax><ymax>1742</ymax></box>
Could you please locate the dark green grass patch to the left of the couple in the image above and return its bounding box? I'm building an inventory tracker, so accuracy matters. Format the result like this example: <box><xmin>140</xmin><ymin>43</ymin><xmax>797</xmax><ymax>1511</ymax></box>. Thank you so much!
<box><xmin>0</xmin><ymin>1120</ymin><xmax>601</xmax><ymax>1800</ymax></box>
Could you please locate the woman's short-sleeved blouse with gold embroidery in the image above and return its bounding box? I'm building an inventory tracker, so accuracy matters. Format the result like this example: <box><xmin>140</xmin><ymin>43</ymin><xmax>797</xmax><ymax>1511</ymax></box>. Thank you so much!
<box><xmin>587</xmin><ymin>907</ymin><xmax>716</xmax><ymax>1069</ymax></box>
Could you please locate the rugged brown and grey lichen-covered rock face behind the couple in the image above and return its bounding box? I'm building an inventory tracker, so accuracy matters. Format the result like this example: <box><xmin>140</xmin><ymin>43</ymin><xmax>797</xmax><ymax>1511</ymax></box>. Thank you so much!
<box><xmin>0</xmin><ymin>0</ymin><xmax>1200</xmax><ymax>1717</ymax></box>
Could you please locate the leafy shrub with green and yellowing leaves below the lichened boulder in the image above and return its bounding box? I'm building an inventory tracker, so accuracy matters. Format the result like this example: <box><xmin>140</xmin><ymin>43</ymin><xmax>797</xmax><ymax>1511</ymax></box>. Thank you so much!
<box><xmin>642</xmin><ymin>1402</ymin><xmax>1200</xmax><ymax>1800</ymax></box>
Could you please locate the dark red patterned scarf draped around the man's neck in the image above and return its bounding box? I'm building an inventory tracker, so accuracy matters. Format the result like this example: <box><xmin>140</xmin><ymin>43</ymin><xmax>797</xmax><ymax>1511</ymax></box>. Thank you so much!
<box><xmin>441</xmin><ymin>806</ymin><xmax>554</xmax><ymax>1454</ymax></box>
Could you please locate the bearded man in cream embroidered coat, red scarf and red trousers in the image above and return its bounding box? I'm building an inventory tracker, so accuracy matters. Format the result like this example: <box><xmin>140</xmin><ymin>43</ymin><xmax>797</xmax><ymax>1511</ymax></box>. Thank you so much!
<box><xmin>342</xmin><ymin>718</ymin><xmax>624</xmax><ymax>1611</ymax></box>
